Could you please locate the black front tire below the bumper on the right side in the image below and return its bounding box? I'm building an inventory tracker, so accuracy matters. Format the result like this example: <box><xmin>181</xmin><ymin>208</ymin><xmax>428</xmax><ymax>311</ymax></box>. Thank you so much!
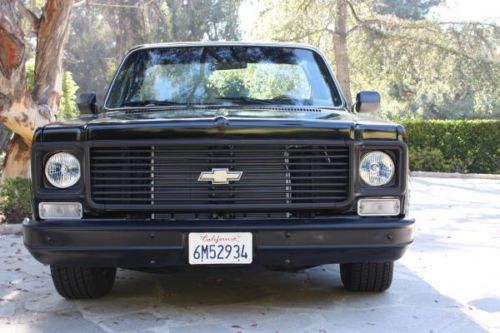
<box><xmin>340</xmin><ymin>261</ymin><xmax>394</xmax><ymax>292</ymax></box>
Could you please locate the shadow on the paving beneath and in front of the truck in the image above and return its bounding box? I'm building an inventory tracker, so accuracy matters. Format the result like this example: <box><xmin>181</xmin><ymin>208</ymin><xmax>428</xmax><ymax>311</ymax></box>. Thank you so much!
<box><xmin>2</xmin><ymin>263</ymin><xmax>485</xmax><ymax>333</ymax></box>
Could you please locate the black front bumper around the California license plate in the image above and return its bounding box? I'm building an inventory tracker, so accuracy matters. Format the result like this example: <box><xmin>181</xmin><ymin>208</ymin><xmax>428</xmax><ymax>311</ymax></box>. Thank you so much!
<box><xmin>23</xmin><ymin>218</ymin><xmax>414</xmax><ymax>268</ymax></box>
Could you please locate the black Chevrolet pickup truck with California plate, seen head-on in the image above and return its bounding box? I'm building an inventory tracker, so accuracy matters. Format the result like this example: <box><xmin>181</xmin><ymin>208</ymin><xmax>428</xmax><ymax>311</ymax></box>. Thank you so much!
<box><xmin>24</xmin><ymin>43</ymin><xmax>414</xmax><ymax>298</ymax></box>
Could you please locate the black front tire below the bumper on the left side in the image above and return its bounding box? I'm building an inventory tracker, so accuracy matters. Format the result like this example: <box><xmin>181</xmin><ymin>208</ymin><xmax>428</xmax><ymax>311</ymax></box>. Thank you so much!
<box><xmin>50</xmin><ymin>265</ymin><xmax>116</xmax><ymax>299</ymax></box>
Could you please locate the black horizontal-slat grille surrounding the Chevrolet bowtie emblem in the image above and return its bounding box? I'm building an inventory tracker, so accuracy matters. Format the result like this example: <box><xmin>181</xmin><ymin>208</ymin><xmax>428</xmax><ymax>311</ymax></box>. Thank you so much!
<box><xmin>90</xmin><ymin>143</ymin><xmax>349</xmax><ymax>210</ymax></box>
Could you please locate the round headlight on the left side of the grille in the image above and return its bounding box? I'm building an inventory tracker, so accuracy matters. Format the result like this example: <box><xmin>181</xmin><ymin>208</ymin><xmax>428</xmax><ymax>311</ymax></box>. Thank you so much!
<box><xmin>45</xmin><ymin>153</ymin><xmax>80</xmax><ymax>188</ymax></box>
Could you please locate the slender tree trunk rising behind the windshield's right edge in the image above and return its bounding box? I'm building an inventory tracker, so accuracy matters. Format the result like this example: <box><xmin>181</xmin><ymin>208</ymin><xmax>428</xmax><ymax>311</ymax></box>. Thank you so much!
<box><xmin>333</xmin><ymin>0</ymin><xmax>352</xmax><ymax>106</ymax></box>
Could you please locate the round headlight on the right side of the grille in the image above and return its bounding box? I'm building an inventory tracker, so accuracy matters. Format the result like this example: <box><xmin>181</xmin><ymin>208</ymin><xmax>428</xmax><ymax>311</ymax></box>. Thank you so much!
<box><xmin>359</xmin><ymin>151</ymin><xmax>394</xmax><ymax>186</ymax></box>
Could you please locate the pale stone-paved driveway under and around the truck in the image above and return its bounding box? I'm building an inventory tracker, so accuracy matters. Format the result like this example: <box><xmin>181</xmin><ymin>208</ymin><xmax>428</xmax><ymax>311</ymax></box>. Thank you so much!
<box><xmin>0</xmin><ymin>178</ymin><xmax>500</xmax><ymax>333</ymax></box>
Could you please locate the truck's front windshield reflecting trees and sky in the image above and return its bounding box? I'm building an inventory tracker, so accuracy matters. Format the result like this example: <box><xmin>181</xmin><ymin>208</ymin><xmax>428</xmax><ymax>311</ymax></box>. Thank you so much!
<box><xmin>106</xmin><ymin>46</ymin><xmax>342</xmax><ymax>109</ymax></box>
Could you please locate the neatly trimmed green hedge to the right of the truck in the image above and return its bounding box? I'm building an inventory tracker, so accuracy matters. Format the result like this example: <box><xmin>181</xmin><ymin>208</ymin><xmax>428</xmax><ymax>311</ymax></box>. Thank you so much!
<box><xmin>401</xmin><ymin>120</ymin><xmax>500</xmax><ymax>174</ymax></box>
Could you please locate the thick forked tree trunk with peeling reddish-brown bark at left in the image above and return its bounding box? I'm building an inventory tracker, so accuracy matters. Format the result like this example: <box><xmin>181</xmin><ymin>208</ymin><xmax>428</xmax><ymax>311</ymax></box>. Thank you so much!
<box><xmin>0</xmin><ymin>0</ymin><xmax>73</xmax><ymax>178</ymax></box>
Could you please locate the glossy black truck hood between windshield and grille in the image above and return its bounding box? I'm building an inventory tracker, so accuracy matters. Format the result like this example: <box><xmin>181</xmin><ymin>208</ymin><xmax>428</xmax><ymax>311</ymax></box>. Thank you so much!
<box><xmin>35</xmin><ymin>107</ymin><xmax>404</xmax><ymax>142</ymax></box>
